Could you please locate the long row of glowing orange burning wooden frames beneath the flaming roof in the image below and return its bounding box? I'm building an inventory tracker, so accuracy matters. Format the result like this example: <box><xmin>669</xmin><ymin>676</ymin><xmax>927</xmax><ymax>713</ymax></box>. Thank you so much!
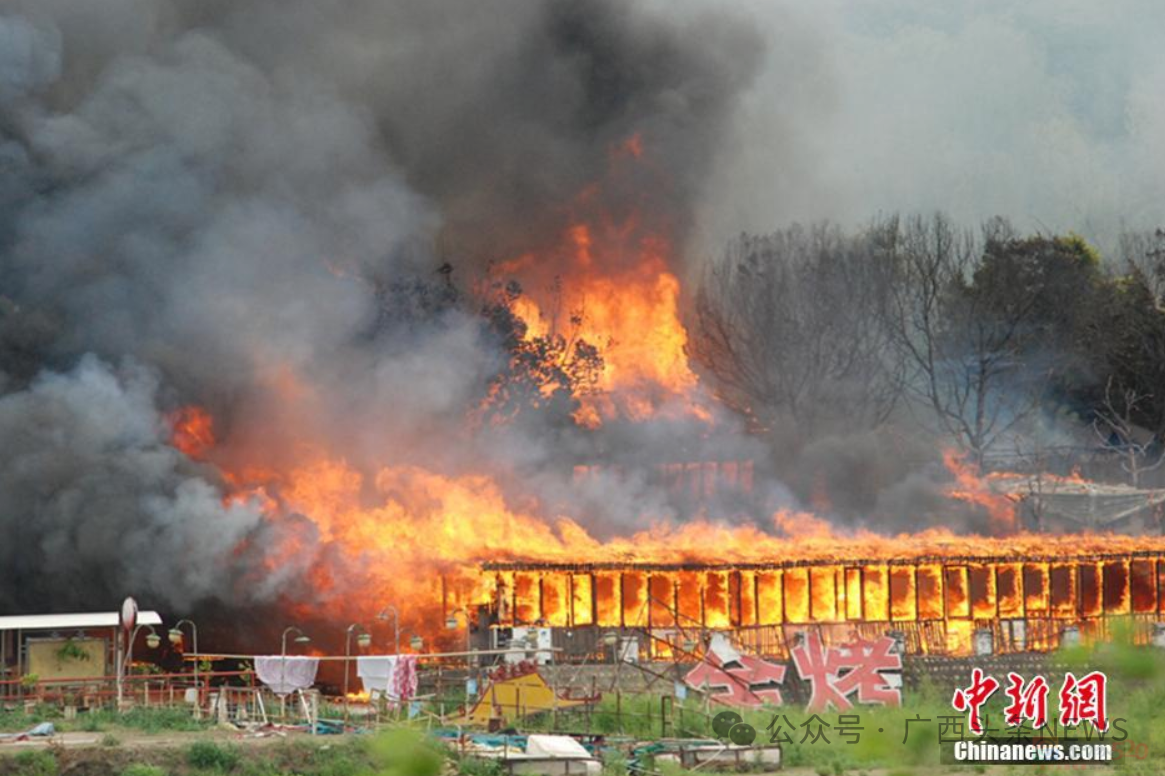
<box><xmin>468</xmin><ymin>551</ymin><xmax>1165</xmax><ymax>658</ymax></box>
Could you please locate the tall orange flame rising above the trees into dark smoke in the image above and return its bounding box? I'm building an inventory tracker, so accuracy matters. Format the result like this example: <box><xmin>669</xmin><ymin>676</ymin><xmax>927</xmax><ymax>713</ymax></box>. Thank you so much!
<box><xmin>496</xmin><ymin>134</ymin><xmax>711</xmax><ymax>428</ymax></box>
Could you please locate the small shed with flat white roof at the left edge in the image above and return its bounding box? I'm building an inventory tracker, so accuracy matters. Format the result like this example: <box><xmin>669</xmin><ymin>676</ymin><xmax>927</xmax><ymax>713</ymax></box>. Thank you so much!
<box><xmin>0</xmin><ymin>612</ymin><xmax>162</xmax><ymax>694</ymax></box>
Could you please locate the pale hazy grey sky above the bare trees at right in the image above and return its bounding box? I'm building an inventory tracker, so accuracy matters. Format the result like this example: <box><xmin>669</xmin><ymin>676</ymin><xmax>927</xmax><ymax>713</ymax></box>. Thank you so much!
<box><xmin>694</xmin><ymin>0</ymin><xmax>1165</xmax><ymax>250</ymax></box>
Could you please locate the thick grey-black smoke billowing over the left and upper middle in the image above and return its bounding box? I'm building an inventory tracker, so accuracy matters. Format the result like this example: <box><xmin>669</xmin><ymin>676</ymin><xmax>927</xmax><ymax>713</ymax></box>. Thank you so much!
<box><xmin>0</xmin><ymin>0</ymin><xmax>761</xmax><ymax>611</ymax></box>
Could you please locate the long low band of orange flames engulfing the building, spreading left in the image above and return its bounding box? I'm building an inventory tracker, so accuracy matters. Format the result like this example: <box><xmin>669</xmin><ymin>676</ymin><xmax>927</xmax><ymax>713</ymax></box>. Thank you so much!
<box><xmin>171</xmin><ymin>384</ymin><xmax>1165</xmax><ymax>651</ymax></box>
